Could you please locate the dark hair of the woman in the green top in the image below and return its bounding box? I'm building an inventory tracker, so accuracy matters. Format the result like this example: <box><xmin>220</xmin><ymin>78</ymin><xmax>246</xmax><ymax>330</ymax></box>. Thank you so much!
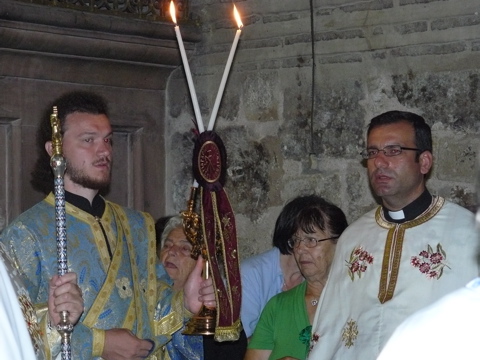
<box><xmin>273</xmin><ymin>194</ymin><xmax>347</xmax><ymax>255</ymax></box>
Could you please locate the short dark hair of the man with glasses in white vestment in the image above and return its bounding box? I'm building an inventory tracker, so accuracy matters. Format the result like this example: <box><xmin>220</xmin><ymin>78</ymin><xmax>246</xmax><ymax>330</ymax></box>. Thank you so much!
<box><xmin>367</xmin><ymin>110</ymin><xmax>433</xmax><ymax>159</ymax></box>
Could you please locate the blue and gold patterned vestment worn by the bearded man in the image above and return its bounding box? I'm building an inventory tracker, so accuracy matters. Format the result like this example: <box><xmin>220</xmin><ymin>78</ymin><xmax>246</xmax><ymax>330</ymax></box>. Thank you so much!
<box><xmin>0</xmin><ymin>194</ymin><xmax>172</xmax><ymax>359</ymax></box>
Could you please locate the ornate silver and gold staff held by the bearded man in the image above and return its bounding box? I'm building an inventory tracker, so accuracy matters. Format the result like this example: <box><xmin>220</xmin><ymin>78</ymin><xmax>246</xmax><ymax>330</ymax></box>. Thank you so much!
<box><xmin>50</xmin><ymin>106</ymin><xmax>73</xmax><ymax>360</ymax></box>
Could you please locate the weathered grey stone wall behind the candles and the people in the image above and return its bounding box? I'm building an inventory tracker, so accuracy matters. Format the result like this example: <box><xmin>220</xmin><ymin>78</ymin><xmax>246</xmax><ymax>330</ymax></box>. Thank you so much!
<box><xmin>166</xmin><ymin>0</ymin><xmax>480</xmax><ymax>258</ymax></box>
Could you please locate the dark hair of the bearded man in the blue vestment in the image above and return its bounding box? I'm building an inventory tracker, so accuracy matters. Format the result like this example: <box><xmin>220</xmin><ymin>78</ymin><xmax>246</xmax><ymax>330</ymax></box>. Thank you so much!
<box><xmin>30</xmin><ymin>91</ymin><xmax>108</xmax><ymax>194</ymax></box>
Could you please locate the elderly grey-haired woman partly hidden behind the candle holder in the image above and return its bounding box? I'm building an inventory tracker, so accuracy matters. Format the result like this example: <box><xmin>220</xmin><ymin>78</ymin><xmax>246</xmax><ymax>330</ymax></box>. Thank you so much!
<box><xmin>155</xmin><ymin>216</ymin><xmax>247</xmax><ymax>360</ymax></box>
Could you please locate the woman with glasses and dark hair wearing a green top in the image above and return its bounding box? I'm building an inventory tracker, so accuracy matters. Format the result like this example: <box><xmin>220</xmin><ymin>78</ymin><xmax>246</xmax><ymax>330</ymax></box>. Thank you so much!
<box><xmin>245</xmin><ymin>197</ymin><xmax>347</xmax><ymax>360</ymax></box>
